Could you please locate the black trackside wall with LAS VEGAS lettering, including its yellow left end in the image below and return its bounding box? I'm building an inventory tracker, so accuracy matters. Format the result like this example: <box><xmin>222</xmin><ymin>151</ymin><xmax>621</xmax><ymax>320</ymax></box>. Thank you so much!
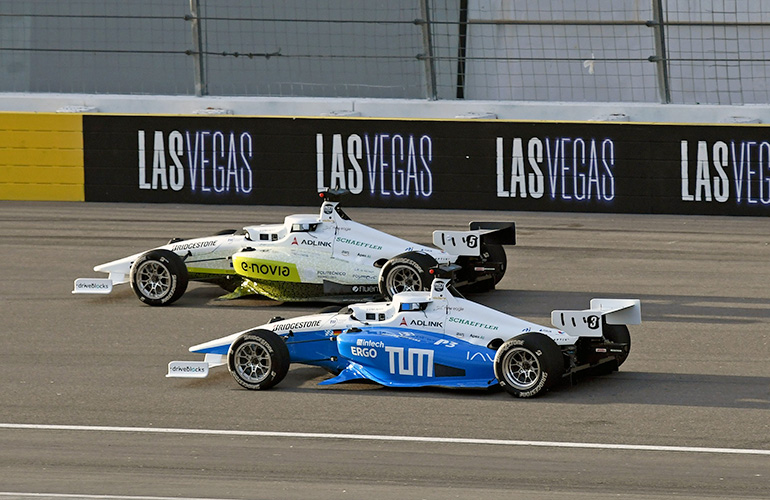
<box><xmin>0</xmin><ymin>113</ymin><xmax>770</xmax><ymax>216</ymax></box>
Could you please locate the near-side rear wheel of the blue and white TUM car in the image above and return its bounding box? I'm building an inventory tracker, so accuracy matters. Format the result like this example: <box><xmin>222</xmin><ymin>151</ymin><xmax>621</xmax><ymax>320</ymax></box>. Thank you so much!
<box><xmin>494</xmin><ymin>333</ymin><xmax>564</xmax><ymax>398</ymax></box>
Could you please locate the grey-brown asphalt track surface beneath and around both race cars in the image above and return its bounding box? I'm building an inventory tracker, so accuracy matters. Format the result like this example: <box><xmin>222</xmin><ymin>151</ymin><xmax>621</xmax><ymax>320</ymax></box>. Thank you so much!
<box><xmin>0</xmin><ymin>201</ymin><xmax>770</xmax><ymax>500</ymax></box>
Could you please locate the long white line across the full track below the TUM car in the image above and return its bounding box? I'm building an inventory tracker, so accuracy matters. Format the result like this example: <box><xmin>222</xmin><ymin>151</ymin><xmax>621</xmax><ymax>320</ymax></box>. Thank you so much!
<box><xmin>0</xmin><ymin>423</ymin><xmax>770</xmax><ymax>456</ymax></box>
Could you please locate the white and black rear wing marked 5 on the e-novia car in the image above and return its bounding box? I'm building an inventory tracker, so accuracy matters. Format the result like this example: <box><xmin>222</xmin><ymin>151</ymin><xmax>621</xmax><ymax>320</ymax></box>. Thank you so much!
<box><xmin>433</xmin><ymin>222</ymin><xmax>516</xmax><ymax>257</ymax></box>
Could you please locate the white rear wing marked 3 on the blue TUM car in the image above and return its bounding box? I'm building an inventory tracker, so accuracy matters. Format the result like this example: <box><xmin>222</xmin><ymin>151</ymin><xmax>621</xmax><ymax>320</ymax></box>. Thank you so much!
<box><xmin>551</xmin><ymin>299</ymin><xmax>642</xmax><ymax>337</ymax></box>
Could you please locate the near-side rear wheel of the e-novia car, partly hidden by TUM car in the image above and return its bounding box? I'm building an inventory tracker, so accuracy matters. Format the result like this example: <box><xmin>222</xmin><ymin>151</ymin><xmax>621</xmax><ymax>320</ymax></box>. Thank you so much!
<box><xmin>378</xmin><ymin>252</ymin><xmax>437</xmax><ymax>300</ymax></box>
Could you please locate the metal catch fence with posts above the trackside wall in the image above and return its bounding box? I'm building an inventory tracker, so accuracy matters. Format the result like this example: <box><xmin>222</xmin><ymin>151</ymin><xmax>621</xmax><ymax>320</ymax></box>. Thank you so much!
<box><xmin>0</xmin><ymin>0</ymin><xmax>770</xmax><ymax>104</ymax></box>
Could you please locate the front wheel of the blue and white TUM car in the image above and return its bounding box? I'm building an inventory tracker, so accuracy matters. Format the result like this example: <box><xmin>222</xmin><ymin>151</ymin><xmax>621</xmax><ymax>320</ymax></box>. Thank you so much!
<box><xmin>227</xmin><ymin>330</ymin><xmax>290</xmax><ymax>391</ymax></box>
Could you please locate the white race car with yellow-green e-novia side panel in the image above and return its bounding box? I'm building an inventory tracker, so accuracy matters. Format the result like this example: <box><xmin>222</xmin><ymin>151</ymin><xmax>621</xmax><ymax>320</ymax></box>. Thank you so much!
<box><xmin>72</xmin><ymin>191</ymin><xmax>516</xmax><ymax>306</ymax></box>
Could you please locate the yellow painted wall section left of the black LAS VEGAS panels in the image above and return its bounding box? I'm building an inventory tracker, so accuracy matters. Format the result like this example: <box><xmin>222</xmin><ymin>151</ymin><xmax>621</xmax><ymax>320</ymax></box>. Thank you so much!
<box><xmin>0</xmin><ymin>113</ymin><xmax>85</xmax><ymax>201</ymax></box>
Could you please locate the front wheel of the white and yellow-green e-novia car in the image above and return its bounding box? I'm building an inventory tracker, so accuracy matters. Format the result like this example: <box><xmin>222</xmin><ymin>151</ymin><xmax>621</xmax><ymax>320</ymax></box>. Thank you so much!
<box><xmin>130</xmin><ymin>250</ymin><xmax>188</xmax><ymax>306</ymax></box>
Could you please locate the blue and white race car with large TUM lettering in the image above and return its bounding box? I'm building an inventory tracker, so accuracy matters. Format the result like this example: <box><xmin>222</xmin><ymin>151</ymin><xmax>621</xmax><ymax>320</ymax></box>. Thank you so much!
<box><xmin>167</xmin><ymin>278</ymin><xmax>641</xmax><ymax>398</ymax></box>
